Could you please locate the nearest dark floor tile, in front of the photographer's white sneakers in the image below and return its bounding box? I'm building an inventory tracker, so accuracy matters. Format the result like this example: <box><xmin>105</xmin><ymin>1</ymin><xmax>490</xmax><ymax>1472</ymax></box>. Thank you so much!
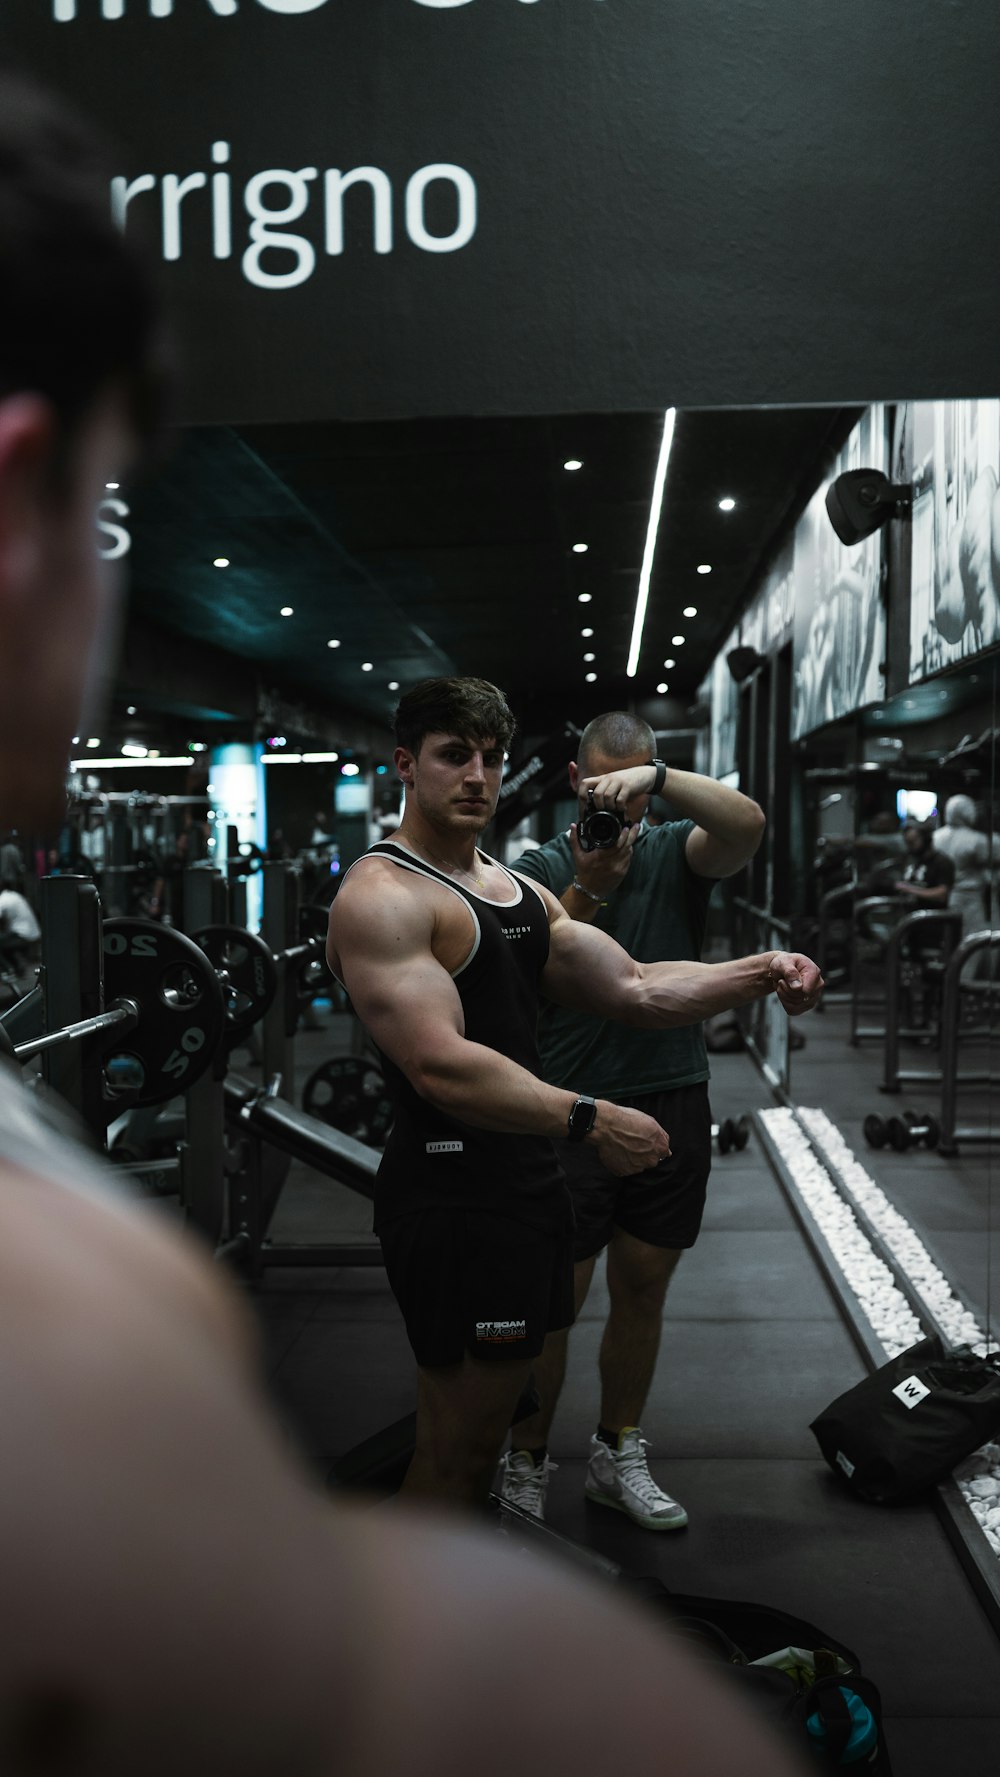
<box><xmin>547</xmin><ymin>1459</ymin><xmax>1000</xmax><ymax>1720</ymax></box>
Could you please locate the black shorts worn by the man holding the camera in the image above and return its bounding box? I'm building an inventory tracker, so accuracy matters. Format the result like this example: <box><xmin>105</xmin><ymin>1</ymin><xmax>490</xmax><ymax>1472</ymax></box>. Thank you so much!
<box><xmin>558</xmin><ymin>1080</ymin><xmax>712</xmax><ymax>1260</ymax></box>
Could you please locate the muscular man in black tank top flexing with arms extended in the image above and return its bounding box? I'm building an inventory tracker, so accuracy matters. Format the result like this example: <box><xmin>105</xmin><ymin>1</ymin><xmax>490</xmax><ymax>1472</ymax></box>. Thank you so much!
<box><xmin>327</xmin><ymin>679</ymin><xmax>822</xmax><ymax>1505</ymax></box>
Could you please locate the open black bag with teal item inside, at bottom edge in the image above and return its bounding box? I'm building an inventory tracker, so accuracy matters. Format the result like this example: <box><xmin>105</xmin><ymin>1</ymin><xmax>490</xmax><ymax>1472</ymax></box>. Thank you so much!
<box><xmin>618</xmin><ymin>1574</ymin><xmax>892</xmax><ymax>1777</ymax></box>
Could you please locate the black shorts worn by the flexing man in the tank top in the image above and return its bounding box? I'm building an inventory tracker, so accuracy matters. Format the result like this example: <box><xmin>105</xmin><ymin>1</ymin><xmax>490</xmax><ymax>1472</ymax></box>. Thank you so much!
<box><xmin>378</xmin><ymin>1203</ymin><xmax>574</xmax><ymax>1368</ymax></box>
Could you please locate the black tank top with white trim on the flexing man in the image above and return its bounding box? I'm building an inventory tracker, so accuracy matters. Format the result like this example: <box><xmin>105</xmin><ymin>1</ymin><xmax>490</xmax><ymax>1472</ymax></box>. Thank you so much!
<box><xmin>346</xmin><ymin>841</ymin><xmax>570</xmax><ymax>1228</ymax></box>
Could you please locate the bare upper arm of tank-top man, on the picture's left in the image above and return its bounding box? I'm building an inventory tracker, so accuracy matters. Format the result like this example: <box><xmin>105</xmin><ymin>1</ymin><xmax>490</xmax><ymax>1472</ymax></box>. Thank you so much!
<box><xmin>327</xmin><ymin>865</ymin><xmax>465</xmax><ymax>1096</ymax></box>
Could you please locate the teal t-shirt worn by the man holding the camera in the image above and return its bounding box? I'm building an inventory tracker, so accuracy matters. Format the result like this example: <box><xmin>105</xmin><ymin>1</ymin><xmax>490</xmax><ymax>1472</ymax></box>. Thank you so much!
<box><xmin>510</xmin><ymin>821</ymin><xmax>716</xmax><ymax>1098</ymax></box>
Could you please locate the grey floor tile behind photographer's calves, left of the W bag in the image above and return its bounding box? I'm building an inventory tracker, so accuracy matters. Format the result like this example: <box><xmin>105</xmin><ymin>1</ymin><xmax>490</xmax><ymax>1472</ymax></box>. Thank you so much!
<box><xmin>551</xmin><ymin>1319</ymin><xmax>865</xmax><ymax>1462</ymax></box>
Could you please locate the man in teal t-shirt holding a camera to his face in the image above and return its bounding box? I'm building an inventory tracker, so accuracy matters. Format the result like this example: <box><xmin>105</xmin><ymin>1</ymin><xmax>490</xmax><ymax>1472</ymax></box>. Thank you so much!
<box><xmin>503</xmin><ymin>709</ymin><xmax>764</xmax><ymax>1530</ymax></box>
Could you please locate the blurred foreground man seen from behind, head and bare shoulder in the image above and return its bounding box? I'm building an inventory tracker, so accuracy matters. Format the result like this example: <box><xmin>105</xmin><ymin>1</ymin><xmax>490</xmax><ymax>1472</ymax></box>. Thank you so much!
<box><xmin>0</xmin><ymin>65</ymin><xmax>808</xmax><ymax>1777</ymax></box>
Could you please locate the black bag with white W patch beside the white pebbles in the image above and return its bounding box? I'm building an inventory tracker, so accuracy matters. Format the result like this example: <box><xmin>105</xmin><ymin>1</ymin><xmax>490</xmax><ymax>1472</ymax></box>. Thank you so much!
<box><xmin>810</xmin><ymin>1338</ymin><xmax>1000</xmax><ymax>1505</ymax></box>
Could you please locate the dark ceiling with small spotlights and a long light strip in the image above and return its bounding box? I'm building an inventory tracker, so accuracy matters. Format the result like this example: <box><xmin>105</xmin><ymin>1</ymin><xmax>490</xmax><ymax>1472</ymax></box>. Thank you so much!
<box><xmin>130</xmin><ymin>407</ymin><xmax>860</xmax><ymax>734</ymax></box>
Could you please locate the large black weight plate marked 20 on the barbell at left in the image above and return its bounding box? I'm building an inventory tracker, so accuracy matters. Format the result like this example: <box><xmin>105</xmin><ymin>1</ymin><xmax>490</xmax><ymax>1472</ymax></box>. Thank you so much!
<box><xmin>99</xmin><ymin>919</ymin><xmax>226</xmax><ymax>1120</ymax></box>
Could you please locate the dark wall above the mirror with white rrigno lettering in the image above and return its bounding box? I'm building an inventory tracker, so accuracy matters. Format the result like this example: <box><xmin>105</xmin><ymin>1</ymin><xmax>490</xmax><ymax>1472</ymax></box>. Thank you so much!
<box><xmin>0</xmin><ymin>0</ymin><xmax>1000</xmax><ymax>421</ymax></box>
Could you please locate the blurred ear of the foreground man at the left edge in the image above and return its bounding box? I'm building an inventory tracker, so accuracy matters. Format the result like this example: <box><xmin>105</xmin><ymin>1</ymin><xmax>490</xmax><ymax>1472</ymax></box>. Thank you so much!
<box><xmin>0</xmin><ymin>394</ymin><xmax>57</xmax><ymax>601</ymax></box>
